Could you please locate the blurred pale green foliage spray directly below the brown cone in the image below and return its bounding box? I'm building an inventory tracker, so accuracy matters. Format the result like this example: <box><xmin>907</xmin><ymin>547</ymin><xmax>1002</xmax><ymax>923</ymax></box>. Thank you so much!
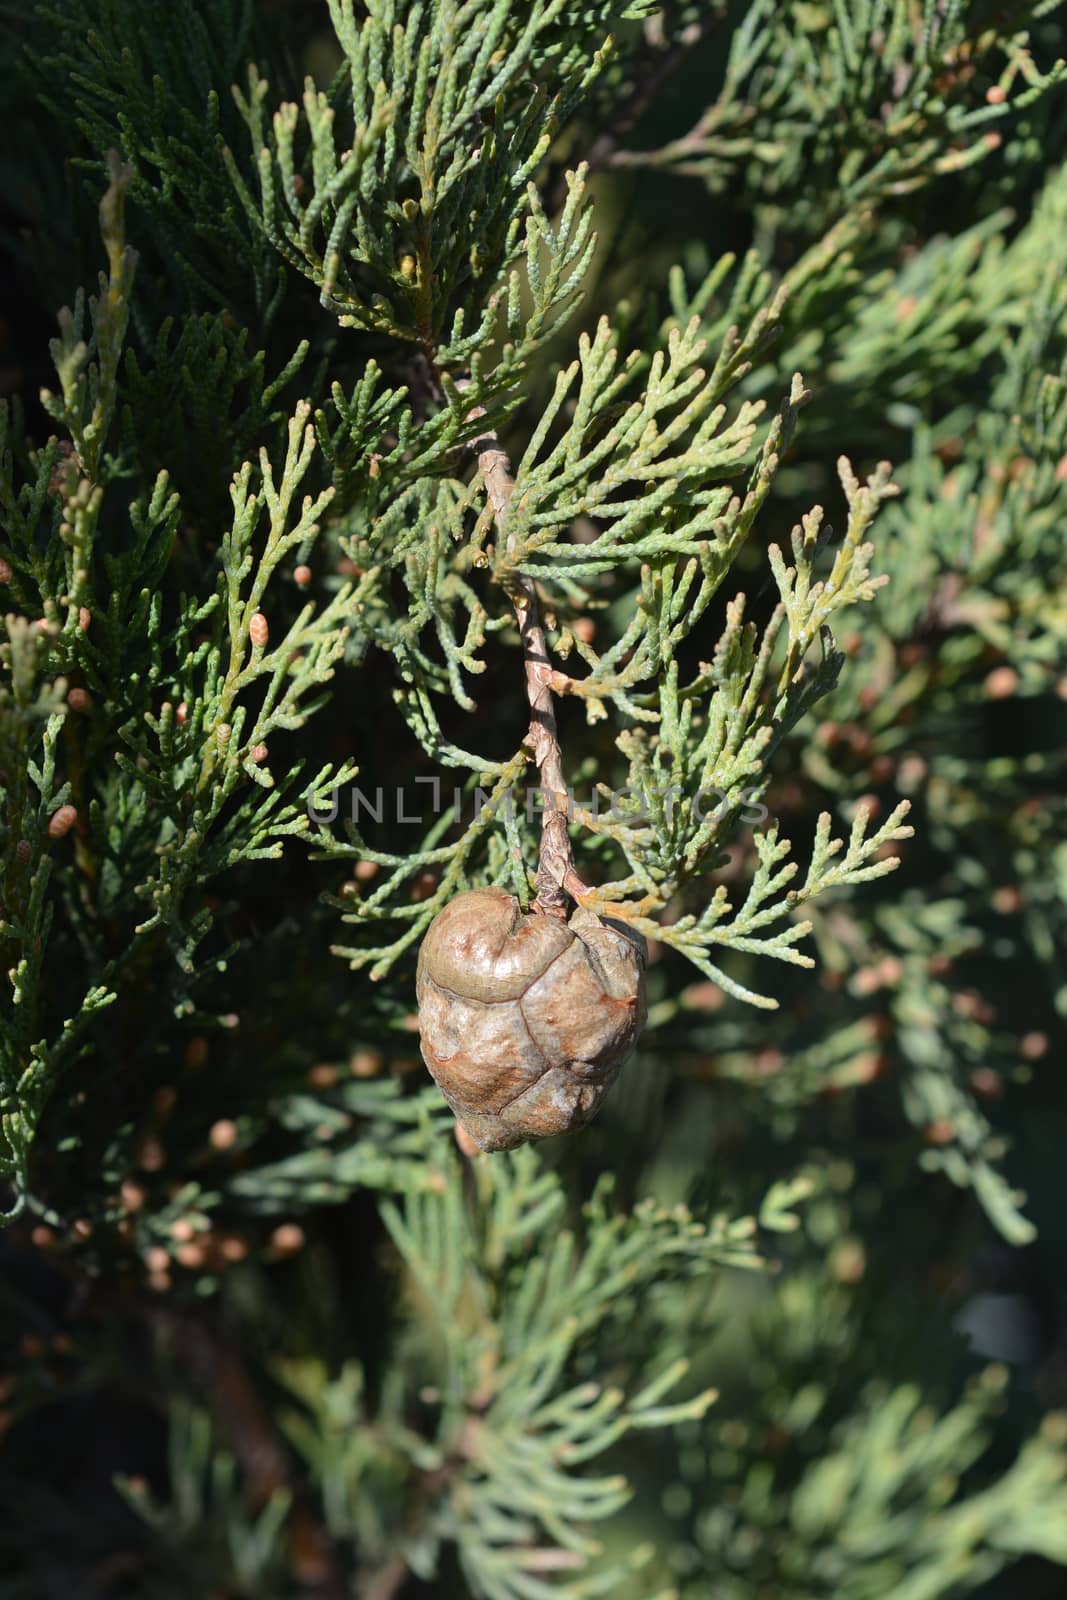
<box><xmin>125</xmin><ymin>1138</ymin><xmax>809</xmax><ymax>1600</ymax></box>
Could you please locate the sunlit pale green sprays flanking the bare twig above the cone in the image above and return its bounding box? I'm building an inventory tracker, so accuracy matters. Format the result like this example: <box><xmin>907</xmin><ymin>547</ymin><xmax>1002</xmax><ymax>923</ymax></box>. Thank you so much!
<box><xmin>316</xmin><ymin>364</ymin><xmax>907</xmax><ymax>1005</ymax></box>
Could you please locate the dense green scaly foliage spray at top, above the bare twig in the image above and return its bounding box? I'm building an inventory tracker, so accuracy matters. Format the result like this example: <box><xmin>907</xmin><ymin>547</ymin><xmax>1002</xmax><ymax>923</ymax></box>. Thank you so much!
<box><xmin>227</xmin><ymin>0</ymin><xmax>646</xmax><ymax>373</ymax></box>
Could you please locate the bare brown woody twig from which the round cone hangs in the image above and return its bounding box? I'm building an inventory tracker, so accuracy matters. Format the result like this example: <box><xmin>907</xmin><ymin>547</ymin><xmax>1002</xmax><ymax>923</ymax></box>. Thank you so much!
<box><xmin>469</xmin><ymin>406</ymin><xmax>589</xmax><ymax>918</ymax></box>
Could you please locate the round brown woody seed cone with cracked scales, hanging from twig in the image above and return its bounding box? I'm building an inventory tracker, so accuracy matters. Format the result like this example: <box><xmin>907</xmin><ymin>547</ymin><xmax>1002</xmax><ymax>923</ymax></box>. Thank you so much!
<box><xmin>416</xmin><ymin>888</ymin><xmax>646</xmax><ymax>1150</ymax></box>
